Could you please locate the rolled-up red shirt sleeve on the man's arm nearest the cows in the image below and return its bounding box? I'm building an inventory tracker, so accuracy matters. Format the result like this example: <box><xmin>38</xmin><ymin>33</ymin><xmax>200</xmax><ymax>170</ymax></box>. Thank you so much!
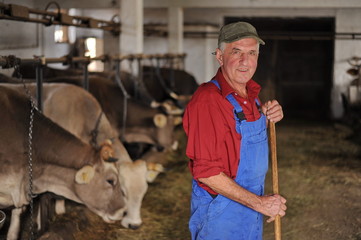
<box><xmin>183</xmin><ymin>97</ymin><xmax>225</xmax><ymax>180</ymax></box>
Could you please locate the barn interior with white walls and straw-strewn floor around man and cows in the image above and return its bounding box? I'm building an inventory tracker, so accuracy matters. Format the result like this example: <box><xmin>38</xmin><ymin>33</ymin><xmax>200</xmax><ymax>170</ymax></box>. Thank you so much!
<box><xmin>0</xmin><ymin>0</ymin><xmax>361</xmax><ymax>240</ymax></box>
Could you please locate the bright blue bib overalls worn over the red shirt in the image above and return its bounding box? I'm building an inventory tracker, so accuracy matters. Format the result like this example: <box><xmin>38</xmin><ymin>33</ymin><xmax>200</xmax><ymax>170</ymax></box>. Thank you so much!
<box><xmin>189</xmin><ymin>80</ymin><xmax>268</xmax><ymax>240</ymax></box>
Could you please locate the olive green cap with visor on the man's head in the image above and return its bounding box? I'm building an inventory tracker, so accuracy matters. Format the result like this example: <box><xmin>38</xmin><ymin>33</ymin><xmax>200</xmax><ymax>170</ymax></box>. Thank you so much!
<box><xmin>218</xmin><ymin>22</ymin><xmax>265</xmax><ymax>47</ymax></box>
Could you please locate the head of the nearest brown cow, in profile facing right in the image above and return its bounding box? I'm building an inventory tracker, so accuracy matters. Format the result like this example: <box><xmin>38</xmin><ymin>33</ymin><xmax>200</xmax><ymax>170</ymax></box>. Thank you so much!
<box><xmin>75</xmin><ymin>143</ymin><xmax>126</xmax><ymax>223</ymax></box>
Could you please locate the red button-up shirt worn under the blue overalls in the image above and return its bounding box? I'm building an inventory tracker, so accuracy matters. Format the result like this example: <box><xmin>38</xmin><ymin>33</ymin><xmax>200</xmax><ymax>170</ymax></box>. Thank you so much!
<box><xmin>183</xmin><ymin>69</ymin><xmax>261</xmax><ymax>194</ymax></box>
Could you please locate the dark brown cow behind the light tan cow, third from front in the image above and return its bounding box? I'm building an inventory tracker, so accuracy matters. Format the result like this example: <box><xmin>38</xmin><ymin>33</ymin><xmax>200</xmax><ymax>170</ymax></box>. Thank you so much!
<box><xmin>41</xmin><ymin>76</ymin><xmax>180</xmax><ymax>155</ymax></box>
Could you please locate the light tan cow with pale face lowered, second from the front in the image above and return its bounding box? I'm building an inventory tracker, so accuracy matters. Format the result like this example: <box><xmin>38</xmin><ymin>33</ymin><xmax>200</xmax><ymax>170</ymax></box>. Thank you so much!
<box><xmin>0</xmin><ymin>83</ymin><xmax>159</xmax><ymax>229</ymax></box>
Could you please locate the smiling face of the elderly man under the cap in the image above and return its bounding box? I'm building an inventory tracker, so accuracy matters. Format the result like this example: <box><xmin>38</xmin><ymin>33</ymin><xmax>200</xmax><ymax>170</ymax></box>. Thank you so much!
<box><xmin>216</xmin><ymin>38</ymin><xmax>259</xmax><ymax>85</ymax></box>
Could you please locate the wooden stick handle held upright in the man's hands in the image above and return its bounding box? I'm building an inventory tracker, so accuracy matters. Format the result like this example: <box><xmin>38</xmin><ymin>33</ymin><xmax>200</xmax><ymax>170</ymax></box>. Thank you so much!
<box><xmin>268</xmin><ymin>121</ymin><xmax>281</xmax><ymax>240</ymax></box>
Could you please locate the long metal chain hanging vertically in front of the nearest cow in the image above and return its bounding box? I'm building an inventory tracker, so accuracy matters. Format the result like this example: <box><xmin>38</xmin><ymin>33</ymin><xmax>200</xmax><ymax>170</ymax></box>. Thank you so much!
<box><xmin>14</xmin><ymin>65</ymin><xmax>38</xmax><ymax>240</ymax></box>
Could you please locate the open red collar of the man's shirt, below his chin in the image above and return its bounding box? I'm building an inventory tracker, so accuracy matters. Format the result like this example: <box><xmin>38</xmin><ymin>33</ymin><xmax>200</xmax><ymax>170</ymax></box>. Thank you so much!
<box><xmin>213</xmin><ymin>68</ymin><xmax>261</xmax><ymax>99</ymax></box>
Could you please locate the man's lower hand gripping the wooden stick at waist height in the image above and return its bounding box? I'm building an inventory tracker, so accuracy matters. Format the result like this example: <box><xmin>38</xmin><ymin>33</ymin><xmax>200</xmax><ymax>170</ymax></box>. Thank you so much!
<box><xmin>259</xmin><ymin>194</ymin><xmax>287</xmax><ymax>223</ymax></box>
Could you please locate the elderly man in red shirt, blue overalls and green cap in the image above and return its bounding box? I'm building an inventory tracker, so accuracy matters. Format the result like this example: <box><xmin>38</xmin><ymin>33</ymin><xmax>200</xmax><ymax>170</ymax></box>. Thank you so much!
<box><xmin>183</xmin><ymin>22</ymin><xmax>286</xmax><ymax>240</ymax></box>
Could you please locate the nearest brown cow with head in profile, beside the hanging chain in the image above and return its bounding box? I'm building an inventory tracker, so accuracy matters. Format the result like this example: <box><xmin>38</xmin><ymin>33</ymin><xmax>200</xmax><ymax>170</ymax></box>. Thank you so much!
<box><xmin>0</xmin><ymin>86</ymin><xmax>125</xmax><ymax>240</ymax></box>
